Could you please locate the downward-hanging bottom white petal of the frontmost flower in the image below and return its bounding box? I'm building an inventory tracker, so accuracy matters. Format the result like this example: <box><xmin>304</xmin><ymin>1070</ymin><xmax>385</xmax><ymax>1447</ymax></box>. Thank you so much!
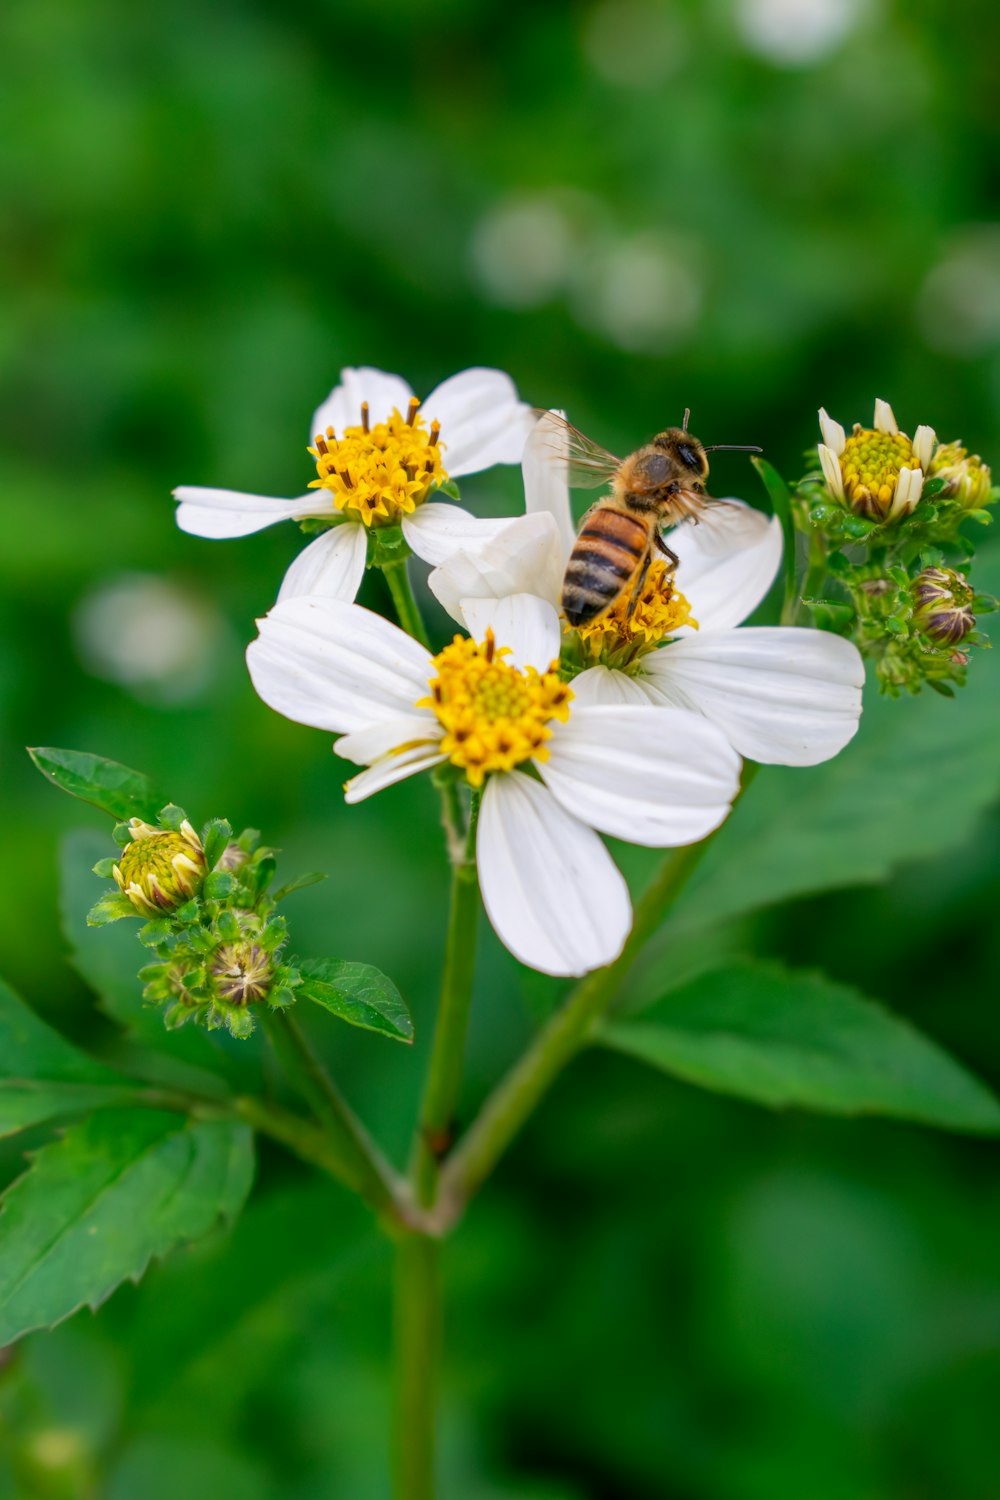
<box><xmin>477</xmin><ymin>771</ymin><xmax>631</xmax><ymax>975</ymax></box>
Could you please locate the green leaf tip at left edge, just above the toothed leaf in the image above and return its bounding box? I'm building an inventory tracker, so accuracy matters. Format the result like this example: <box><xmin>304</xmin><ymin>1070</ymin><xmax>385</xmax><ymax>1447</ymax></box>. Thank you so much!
<box><xmin>0</xmin><ymin>981</ymin><xmax>136</xmax><ymax>1136</ymax></box>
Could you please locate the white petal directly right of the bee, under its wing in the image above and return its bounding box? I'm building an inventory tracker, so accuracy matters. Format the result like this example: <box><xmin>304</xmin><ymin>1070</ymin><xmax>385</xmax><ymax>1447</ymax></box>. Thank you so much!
<box><xmin>669</xmin><ymin>501</ymin><xmax>781</xmax><ymax>633</ymax></box>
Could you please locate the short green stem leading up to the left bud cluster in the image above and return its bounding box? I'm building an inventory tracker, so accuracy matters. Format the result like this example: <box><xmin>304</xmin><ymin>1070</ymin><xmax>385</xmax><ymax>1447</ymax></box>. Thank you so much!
<box><xmin>265</xmin><ymin>1011</ymin><xmax>408</xmax><ymax>1226</ymax></box>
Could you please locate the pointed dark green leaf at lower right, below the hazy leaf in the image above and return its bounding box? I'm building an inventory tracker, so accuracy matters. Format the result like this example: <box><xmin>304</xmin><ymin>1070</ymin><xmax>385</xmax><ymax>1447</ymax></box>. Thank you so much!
<box><xmin>600</xmin><ymin>962</ymin><xmax>1000</xmax><ymax>1134</ymax></box>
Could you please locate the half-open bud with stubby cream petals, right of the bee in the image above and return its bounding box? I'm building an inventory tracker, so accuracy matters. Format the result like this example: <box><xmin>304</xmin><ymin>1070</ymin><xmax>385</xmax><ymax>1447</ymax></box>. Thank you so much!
<box><xmin>817</xmin><ymin>401</ymin><xmax>936</xmax><ymax>521</ymax></box>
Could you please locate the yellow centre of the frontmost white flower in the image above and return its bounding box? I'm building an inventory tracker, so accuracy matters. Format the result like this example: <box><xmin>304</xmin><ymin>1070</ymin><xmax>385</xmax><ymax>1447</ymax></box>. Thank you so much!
<box><xmin>417</xmin><ymin>630</ymin><xmax>573</xmax><ymax>786</ymax></box>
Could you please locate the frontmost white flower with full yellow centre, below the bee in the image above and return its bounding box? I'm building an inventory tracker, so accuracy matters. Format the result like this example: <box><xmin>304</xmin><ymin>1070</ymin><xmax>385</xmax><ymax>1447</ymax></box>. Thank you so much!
<box><xmin>247</xmin><ymin>594</ymin><xmax>739</xmax><ymax>975</ymax></box>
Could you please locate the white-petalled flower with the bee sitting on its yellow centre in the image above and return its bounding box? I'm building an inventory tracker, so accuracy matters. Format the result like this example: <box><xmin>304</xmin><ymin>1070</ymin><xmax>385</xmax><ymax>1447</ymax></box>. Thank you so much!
<box><xmin>430</xmin><ymin>419</ymin><xmax>865</xmax><ymax>765</ymax></box>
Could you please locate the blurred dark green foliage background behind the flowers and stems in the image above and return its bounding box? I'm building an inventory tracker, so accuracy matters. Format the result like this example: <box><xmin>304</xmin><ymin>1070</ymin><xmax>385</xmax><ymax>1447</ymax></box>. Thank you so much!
<box><xmin>0</xmin><ymin>0</ymin><xmax>1000</xmax><ymax>1500</ymax></box>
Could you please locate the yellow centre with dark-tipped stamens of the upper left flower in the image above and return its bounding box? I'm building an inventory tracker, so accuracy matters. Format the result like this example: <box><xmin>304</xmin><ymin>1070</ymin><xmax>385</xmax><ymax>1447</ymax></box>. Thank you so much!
<box><xmin>309</xmin><ymin>396</ymin><xmax>448</xmax><ymax>527</ymax></box>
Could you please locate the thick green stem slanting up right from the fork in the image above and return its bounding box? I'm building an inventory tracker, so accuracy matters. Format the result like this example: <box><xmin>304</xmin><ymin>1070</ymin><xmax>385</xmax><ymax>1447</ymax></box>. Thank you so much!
<box><xmin>435</xmin><ymin>764</ymin><xmax>757</xmax><ymax>1230</ymax></box>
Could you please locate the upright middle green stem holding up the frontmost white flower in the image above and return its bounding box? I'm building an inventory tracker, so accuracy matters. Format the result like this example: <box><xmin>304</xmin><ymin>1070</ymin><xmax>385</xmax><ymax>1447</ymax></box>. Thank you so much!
<box><xmin>412</xmin><ymin>794</ymin><xmax>480</xmax><ymax>1206</ymax></box>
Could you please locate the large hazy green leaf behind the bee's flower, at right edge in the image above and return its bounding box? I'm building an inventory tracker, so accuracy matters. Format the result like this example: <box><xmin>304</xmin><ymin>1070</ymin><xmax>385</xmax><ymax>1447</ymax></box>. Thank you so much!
<box><xmin>659</xmin><ymin>546</ymin><xmax>1000</xmax><ymax>932</ymax></box>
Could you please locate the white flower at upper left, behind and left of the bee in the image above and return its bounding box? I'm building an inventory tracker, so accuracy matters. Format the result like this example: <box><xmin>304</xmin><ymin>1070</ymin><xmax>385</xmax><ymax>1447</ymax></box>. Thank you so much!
<box><xmin>174</xmin><ymin>368</ymin><xmax>535</xmax><ymax>602</ymax></box>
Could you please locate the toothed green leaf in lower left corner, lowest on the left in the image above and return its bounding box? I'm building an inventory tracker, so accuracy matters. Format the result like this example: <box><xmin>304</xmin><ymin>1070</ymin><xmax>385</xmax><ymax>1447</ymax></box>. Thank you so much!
<box><xmin>0</xmin><ymin>1110</ymin><xmax>253</xmax><ymax>1344</ymax></box>
